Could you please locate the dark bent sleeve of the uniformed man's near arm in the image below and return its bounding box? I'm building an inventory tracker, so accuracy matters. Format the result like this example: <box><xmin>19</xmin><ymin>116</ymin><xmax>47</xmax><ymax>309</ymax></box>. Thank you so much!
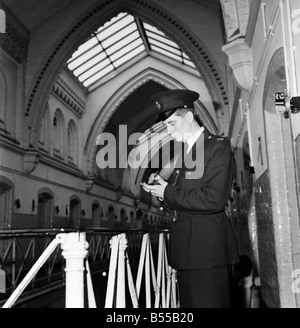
<box><xmin>164</xmin><ymin>141</ymin><xmax>236</xmax><ymax>214</ymax></box>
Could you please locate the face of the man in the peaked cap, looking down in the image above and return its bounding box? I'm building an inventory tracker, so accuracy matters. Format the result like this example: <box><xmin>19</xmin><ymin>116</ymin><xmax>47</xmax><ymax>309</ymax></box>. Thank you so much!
<box><xmin>164</xmin><ymin>113</ymin><xmax>190</xmax><ymax>142</ymax></box>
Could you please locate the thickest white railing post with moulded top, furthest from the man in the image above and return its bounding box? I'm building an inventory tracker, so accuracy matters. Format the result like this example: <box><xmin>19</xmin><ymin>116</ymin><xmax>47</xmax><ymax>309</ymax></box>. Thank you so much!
<box><xmin>61</xmin><ymin>232</ymin><xmax>88</xmax><ymax>308</ymax></box>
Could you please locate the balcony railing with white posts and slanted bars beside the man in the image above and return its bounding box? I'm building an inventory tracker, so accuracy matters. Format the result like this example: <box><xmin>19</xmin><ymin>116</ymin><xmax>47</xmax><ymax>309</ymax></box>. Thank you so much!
<box><xmin>0</xmin><ymin>228</ymin><xmax>178</xmax><ymax>307</ymax></box>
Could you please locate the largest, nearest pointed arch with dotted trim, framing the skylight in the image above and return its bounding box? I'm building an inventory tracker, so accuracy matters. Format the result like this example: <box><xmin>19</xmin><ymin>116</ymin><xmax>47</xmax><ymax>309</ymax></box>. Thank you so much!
<box><xmin>25</xmin><ymin>0</ymin><xmax>228</xmax><ymax>146</ymax></box>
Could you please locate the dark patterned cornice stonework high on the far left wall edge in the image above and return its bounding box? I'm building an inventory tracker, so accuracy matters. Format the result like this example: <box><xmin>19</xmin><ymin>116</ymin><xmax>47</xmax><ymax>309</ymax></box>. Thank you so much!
<box><xmin>0</xmin><ymin>23</ymin><xmax>28</xmax><ymax>64</ymax></box>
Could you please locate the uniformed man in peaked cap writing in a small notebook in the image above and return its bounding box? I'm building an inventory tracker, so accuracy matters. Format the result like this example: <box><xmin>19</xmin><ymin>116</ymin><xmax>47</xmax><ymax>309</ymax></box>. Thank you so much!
<box><xmin>142</xmin><ymin>89</ymin><xmax>238</xmax><ymax>308</ymax></box>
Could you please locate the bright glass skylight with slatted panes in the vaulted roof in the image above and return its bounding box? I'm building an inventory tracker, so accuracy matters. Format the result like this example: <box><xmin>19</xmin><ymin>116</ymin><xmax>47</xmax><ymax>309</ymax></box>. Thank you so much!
<box><xmin>67</xmin><ymin>13</ymin><xmax>195</xmax><ymax>87</ymax></box>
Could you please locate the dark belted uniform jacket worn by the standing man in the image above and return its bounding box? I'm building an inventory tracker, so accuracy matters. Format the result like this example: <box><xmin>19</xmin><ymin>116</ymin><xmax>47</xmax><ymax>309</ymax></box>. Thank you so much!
<box><xmin>164</xmin><ymin>129</ymin><xmax>238</xmax><ymax>269</ymax></box>
